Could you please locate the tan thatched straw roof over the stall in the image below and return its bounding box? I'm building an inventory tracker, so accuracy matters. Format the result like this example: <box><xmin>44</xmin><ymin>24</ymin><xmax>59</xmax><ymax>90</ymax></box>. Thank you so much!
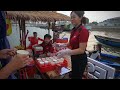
<box><xmin>7</xmin><ymin>11</ymin><xmax>70</xmax><ymax>22</ymax></box>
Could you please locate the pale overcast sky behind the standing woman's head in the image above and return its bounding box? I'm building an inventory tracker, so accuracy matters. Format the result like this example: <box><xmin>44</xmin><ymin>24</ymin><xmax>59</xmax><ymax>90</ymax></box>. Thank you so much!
<box><xmin>57</xmin><ymin>11</ymin><xmax>120</xmax><ymax>22</ymax></box>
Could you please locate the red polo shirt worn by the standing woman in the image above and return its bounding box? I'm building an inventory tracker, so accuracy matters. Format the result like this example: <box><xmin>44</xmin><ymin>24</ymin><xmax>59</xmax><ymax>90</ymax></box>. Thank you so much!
<box><xmin>69</xmin><ymin>25</ymin><xmax>89</xmax><ymax>49</ymax></box>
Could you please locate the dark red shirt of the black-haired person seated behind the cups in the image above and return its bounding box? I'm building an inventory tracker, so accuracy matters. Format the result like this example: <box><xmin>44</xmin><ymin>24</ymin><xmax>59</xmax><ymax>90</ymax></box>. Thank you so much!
<box><xmin>40</xmin><ymin>42</ymin><xmax>54</xmax><ymax>54</ymax></box>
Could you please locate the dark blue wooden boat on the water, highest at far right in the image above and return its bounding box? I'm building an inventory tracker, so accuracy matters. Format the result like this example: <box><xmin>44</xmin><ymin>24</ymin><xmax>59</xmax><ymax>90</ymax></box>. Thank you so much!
<box><xmin>94</xmin><ymin>35</ymin><xmax>120</xmax><ymax>48</ymax></box>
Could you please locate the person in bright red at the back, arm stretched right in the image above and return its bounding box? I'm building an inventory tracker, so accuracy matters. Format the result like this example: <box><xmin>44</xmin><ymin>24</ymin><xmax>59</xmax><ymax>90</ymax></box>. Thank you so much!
<box><xmin>27</xmin><ymin>32</ymin><xmax>44</xmax><ymax>49</ymax></box>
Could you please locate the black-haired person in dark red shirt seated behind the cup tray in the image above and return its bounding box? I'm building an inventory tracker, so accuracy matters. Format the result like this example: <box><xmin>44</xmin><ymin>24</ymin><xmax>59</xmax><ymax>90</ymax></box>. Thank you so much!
<box><xmin>36</xmin><ymin>34</ymin><xmax>54</xmax><ymax>56</ymax></box>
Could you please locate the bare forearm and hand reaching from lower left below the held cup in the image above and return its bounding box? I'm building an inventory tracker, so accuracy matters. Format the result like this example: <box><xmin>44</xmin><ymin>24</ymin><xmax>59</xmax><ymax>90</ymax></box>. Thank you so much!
<box><xmin>0</xmin><ymin>55</ymin><xmax>30</xmax><ymax>79</ymax></box>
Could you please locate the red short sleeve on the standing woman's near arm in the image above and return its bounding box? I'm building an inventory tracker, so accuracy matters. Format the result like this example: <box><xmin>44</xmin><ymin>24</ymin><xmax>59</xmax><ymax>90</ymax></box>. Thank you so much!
<box><xmin>79</xmin><ymin>29</ymin><xmax>89</xmax><ymax>43</ymax></box>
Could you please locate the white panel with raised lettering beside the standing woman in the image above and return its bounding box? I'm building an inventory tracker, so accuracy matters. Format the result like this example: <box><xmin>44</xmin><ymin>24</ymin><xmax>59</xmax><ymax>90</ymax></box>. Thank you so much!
<box><xmin>88</xmin><ymin>57</ymin><xmax>115</xmax><ymax>79</ymax></box>
